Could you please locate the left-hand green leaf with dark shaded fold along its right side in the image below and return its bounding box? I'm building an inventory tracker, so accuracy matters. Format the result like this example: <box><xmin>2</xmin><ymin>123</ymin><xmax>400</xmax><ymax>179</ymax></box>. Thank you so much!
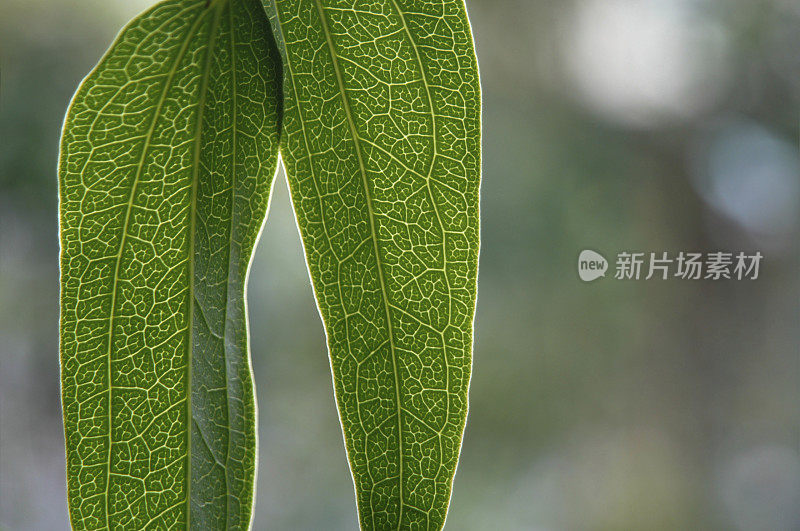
<box><xmin>59</xmin><ymin>0</ymin><xmax>281</xmax><ymax>529</ymax></box>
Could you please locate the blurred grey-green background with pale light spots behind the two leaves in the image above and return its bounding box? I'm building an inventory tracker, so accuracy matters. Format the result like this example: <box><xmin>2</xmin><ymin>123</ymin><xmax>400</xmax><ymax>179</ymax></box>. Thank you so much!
<box><xmin>0</xmin><ymin>0</ymin><xmax>800</xmax><ymax>530</ymax></box>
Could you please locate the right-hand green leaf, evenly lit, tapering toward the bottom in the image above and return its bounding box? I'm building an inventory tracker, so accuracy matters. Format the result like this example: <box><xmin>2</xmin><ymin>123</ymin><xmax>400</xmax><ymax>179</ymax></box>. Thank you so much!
<box><xmin>267</xmin><ymin>0</ymin><xmax>481</xmax><ymax>529</ymax></box>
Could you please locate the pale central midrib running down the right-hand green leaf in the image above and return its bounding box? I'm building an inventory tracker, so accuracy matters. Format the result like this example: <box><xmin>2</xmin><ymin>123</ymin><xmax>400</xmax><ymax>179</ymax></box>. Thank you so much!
<box><xmin>314</xmin><ymin>0</ymin><xmax>405</xmax><ymax>529</ymax></box>
